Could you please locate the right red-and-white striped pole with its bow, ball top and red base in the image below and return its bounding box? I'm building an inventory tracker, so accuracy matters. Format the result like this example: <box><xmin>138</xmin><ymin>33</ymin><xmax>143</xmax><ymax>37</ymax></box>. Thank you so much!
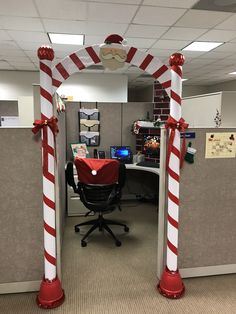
<box><xmin>158</xmin><ymin>53</ymin><xmax>188</xmax><ymax>299</ymax></box>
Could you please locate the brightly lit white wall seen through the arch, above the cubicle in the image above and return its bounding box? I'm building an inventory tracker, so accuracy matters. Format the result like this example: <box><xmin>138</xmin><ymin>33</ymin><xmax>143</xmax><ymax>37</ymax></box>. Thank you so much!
<box><xmin>57</xmin><ymin>73</ymin><xmax>128</xmax><ymax>102</ymax></box>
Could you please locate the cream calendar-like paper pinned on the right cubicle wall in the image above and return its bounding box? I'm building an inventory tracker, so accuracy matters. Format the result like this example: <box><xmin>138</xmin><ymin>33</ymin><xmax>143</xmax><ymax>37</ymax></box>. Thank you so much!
<box><xmin>205</xmin><ymin>132</ymin><xmax>236</xmax><ymax>158</ymax></box>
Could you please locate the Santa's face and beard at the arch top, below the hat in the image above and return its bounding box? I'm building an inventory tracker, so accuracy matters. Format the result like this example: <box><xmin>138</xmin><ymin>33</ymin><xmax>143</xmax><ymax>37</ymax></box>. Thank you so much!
<box><xmin>99</xmin><ymin>46</ymin><xmax>127</xmax><ymax>71</ymax></box>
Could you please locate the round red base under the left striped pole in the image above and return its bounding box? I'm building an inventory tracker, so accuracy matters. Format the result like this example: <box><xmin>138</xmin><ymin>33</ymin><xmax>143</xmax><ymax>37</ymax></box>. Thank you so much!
<box><xmin>36</xmin><ymin>277</ymin><xmax>65</xmax><ymax>309</ymax></box>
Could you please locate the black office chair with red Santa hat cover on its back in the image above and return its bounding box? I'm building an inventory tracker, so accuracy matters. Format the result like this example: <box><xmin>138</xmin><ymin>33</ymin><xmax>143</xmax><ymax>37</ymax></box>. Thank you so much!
<box><xmin>66</xmin><ymin>158</ymin><xmax>129</xmax><ymax>247</ymax></box>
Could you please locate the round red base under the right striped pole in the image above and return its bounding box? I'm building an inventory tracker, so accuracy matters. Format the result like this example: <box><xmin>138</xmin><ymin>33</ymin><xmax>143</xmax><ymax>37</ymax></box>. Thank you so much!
<box><xmin>157</xmin><ymin>267</ymin><xmax>185</xmax><ymax>299</ymax></box>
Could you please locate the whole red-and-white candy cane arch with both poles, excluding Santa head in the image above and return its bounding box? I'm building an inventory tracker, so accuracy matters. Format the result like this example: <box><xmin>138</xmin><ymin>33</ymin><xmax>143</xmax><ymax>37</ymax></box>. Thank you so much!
<box><xmin>34</xmin><ymin>38</ymin><xmax>184</xmax><ymax>308</ymax></box>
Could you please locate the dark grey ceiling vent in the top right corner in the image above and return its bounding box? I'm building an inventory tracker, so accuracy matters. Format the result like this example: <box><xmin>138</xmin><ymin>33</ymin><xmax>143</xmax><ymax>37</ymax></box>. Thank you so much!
<box><xmin>192</xmin><ymin>0</ymin><xmax>236</xmax><ymax>13</ymax></box>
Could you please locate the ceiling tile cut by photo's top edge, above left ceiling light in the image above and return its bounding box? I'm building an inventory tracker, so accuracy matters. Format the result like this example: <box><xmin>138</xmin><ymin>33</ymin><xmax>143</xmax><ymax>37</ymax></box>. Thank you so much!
<box><xmin>35</xmin><ymin>0</ymin><xmax>87</xmax><ymax>20</ymax></box>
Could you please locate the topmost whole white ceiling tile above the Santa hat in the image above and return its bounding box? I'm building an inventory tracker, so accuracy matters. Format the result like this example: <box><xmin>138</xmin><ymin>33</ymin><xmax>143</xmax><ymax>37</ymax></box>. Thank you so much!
<box><xmin>88</xmin><ymin>3</ymin><xmax>138</xmax><ymax>23</ymax></box>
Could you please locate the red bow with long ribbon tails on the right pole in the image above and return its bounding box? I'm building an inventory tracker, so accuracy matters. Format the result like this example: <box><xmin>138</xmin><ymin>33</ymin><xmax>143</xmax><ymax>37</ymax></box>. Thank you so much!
<box><xmin>165</xmin><ymin>116</ymin><xmax>188</xmax><ymax>168</ymax></box>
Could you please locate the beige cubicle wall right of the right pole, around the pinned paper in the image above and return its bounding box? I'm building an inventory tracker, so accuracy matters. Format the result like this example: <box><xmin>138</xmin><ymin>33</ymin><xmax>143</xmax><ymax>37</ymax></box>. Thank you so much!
<box><xmin>179</xmin><ymin>128</ymin><xmax>236</xmax><ymax>277</ymax></box>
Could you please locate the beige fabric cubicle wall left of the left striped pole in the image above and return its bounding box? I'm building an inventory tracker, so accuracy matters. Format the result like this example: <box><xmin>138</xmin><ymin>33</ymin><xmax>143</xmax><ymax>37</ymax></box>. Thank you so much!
<box><xmin>0</xmin><ymin>128</ymin><xmax>43</xmax><ymax>293</ymax></box>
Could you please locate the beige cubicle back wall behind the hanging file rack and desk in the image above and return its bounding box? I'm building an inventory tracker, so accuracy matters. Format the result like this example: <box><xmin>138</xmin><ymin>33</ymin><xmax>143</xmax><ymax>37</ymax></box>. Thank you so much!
<box><xmin>66</xmin><ymin>102</ymin><xmax>153</xmax><ymax>160</ymax></box>
